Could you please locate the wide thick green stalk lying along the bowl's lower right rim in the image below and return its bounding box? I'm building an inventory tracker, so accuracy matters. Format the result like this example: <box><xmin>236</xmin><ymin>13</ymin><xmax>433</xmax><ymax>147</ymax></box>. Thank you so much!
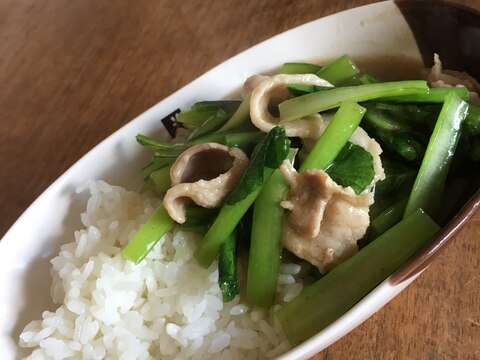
<box><xmin>277</xmin><ymin>209</ymin><xmax>439</xmax><ymax>346</ymax></box>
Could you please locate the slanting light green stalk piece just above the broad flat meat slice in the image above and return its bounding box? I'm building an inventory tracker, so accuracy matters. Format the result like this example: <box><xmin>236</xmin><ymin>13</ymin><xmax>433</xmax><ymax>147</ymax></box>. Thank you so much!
<box><xmin>300</xmin><ymin>102</ymin><xmax>366</xmax><ymax>171</ymax></box>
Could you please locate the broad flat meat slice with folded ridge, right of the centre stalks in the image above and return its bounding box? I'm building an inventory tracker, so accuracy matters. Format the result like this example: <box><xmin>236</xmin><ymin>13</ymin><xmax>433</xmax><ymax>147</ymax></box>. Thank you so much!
<box><xmin>280</xmin><ymin>161</ymin><xmax>373</xmax><ymax>273</ymax></box>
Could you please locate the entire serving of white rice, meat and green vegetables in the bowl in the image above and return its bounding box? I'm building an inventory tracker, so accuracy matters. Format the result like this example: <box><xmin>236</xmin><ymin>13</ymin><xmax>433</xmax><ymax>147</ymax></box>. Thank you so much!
<box><xmin>19</xmin><ymin>55</ymin><xmax>480</xmax><ymax>359</ymax></box>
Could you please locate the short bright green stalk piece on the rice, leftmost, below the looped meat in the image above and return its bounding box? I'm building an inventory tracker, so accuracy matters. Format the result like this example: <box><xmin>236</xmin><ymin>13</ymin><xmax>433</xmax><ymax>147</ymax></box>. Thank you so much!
<box><xmin>122</xmin><ymin>205</ymin><xmax>174</xmax><ymax>264</ymax></box>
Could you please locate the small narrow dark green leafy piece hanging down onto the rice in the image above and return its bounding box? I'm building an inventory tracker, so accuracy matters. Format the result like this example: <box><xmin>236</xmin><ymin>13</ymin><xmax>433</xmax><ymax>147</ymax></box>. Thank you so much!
<box><xmin>218</xmin><ymin>231</ymin><xmax>240</xmax><ymax>302</ymax></box>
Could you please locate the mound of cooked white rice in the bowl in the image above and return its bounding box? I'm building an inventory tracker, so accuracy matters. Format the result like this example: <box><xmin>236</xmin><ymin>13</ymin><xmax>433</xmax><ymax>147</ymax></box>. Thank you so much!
<box><xmin>19</xmin><ymin>181</ymin><xmax>310</xmax><ymax>360</ymax></box>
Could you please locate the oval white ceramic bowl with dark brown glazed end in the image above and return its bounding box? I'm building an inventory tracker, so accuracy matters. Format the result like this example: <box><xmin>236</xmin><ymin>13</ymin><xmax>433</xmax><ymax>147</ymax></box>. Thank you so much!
<box><xmin>0</xmin><ymin>1</ymin><xmax>480</xmax><ymax>359</ymax></box>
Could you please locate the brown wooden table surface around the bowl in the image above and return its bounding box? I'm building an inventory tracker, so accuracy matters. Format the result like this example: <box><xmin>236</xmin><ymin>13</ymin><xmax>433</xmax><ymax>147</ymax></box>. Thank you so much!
<box><xmin>0</xmin><ymin>0</ymin><xmax>480</xmax><ymax>360</ymax></box>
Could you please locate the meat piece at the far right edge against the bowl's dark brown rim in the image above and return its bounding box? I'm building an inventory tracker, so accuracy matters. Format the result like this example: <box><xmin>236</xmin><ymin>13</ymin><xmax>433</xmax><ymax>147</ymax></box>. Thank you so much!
<box><xmin>427</xmin><ymin>54</ymin><xmax>480</xmax><ymax>105</ymax></box>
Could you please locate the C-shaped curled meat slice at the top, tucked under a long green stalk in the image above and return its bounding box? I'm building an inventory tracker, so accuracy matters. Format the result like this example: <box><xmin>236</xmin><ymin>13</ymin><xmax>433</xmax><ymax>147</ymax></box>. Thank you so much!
<box><xmin>245</xmin><ymin>74</ymin><xmax>332</xmax><ymax>138</ymax></box>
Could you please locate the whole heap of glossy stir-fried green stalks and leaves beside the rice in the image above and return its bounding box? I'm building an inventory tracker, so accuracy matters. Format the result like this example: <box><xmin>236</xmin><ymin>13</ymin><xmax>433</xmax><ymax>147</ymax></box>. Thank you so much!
<box><xmin>122</xmin><ymin>55</ymin><xmax>480</xmax><ymax>344</ymax></box>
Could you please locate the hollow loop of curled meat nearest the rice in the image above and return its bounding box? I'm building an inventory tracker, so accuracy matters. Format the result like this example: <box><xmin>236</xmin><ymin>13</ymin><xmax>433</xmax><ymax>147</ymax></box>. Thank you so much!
<box><xmin>163</xmin><ymin>143</ymin><xmax>248</xmax><ymax>223</ymax></box>
